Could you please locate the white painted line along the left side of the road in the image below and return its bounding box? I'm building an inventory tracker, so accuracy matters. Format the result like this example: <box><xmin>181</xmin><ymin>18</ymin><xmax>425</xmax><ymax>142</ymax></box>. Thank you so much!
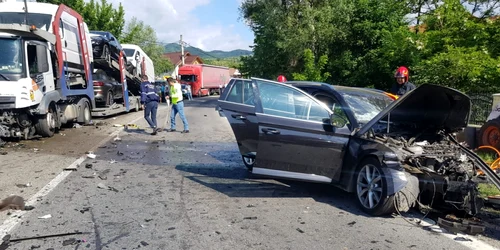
<box><xmin>0</xmin><ymin>108</ymin><xmax>165</xmax><ymax>241</ymax></box>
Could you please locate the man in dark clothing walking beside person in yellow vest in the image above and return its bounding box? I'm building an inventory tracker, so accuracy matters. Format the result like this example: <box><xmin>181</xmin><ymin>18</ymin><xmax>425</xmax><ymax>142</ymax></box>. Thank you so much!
<box><xmin>141</xmin><ymin>75</ymin><xmax>160</xmax><ymax>135</ymax></box>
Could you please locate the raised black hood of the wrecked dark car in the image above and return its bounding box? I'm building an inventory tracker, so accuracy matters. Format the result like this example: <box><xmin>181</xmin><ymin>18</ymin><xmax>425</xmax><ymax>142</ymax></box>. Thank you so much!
<box><xmin>356</xmin><ymin>84</ymin><xmax>471</xmax><ymax>136</ymax></box>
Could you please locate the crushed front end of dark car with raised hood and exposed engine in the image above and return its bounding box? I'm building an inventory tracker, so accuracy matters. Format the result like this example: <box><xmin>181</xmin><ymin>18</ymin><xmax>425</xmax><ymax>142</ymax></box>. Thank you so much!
<box><xmin>357</xmin><ymin>85</ymin><xmax>500</xmax><ymax>215</ymax></box>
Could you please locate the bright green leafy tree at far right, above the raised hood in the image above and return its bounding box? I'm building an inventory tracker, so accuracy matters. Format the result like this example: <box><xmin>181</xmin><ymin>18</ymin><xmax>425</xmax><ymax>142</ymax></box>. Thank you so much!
<box><xmin>414</xmin><ymin>0</ymin><xmax>500</xmax><ymax>92</ymax></box>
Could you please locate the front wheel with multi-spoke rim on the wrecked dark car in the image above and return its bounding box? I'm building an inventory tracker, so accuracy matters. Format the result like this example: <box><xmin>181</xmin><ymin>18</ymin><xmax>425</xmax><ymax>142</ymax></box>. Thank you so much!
<box><xmin>355</xmin><ymin>158</ymin><xmax>396</xmax><ymax>216</ymax></box>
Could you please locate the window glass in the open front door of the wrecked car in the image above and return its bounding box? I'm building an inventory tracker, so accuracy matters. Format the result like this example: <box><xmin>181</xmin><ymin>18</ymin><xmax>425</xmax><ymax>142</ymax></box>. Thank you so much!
<box><xmin>257</xmin><ymin>81</ymin><xmax>330</xmax><ymax>121</ymax></box>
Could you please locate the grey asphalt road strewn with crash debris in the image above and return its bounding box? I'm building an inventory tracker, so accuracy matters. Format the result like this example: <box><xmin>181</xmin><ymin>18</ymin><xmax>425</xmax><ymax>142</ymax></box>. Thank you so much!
<box><xmin>0</xmin><ymin>97</ymin><xmax>500</xmax><ymax>249</ymax></box>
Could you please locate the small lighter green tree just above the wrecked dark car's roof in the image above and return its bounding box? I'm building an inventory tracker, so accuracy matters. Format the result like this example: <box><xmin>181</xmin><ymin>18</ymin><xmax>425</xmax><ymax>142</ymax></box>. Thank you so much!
<box><xmin>292</xmin><ymin>49</ymin><xmax>330</xmax><ymax>82</ymax></box>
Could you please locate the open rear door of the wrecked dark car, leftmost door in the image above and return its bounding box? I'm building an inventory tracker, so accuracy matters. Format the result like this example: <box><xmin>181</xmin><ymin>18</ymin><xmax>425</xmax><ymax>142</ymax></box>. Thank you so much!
<box><xmin>218</xmin><ymin>79</ymin><xmax>259</xmax><ymax>156</ymax></box>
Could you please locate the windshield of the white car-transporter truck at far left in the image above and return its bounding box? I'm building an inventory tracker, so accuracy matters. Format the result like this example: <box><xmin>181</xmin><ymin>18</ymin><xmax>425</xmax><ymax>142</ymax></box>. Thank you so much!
<box><xmin>0</xmin><ymin>38</ymin><xmax>23</xmax><ymax>74</ymax></box>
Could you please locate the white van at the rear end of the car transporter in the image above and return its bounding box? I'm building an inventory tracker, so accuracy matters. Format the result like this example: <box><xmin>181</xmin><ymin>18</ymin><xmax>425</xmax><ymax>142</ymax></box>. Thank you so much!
<box><xmin>122</xmin><ymin>44</ymin><xmax>155</xmax><ymax>81</ymax></box>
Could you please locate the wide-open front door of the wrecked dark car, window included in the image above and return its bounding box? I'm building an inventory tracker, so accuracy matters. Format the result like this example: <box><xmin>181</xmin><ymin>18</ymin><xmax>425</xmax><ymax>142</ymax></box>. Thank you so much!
<box><xmin>252</xmin><ymin>79</ymin><xmax>350</xmax><ymax>183</ymax></box>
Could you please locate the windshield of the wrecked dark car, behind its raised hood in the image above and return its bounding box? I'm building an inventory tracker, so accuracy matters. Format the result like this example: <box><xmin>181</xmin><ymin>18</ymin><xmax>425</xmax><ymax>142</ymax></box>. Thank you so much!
<box><xmin>338</xmin><ymin>89</ymin><xmax>393</xmax><ymax>124</ymax></box>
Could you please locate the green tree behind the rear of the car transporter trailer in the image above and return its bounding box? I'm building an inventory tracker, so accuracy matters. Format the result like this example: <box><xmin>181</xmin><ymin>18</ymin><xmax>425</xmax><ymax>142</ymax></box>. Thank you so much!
<box><xmin>119</xmin><ymin>17</ymin><xmax>174</xmax><ymax>75</ymax></box>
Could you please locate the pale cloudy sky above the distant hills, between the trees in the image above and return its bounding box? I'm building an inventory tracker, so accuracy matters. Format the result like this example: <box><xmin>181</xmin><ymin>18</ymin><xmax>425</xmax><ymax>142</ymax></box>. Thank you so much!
<box><xmin>108</xmin><ymin>0</ymin><xmax>251</xmax><ymax>51</ymax></box>
